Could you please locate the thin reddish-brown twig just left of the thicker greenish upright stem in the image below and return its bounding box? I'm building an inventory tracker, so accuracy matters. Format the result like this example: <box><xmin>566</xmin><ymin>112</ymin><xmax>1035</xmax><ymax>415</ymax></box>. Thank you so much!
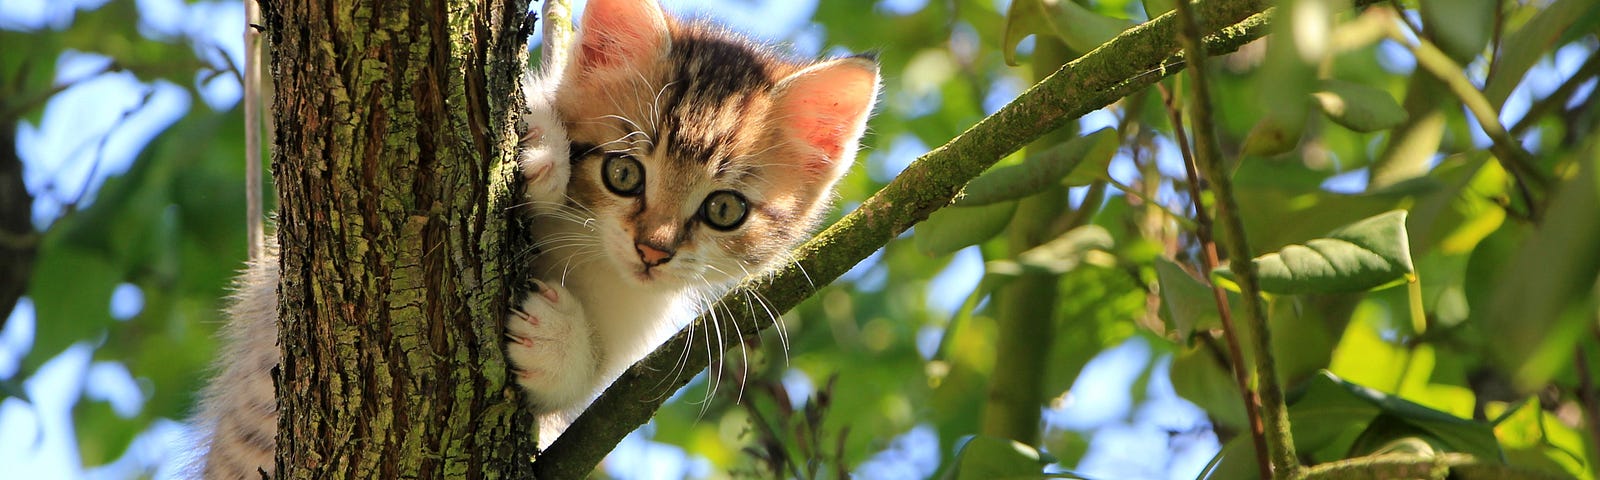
<box><xmin>1162</xmin><ymin>86</ymin><xmax>1272</xmax><ymax>478</ymax></box>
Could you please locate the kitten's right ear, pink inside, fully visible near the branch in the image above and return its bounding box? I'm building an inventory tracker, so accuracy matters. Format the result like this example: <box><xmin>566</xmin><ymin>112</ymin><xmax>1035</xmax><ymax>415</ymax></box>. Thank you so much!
<box><xmin>768</xmin><ymin>56</ymin><xmax>878</xmax><ymax>182</ymax></box>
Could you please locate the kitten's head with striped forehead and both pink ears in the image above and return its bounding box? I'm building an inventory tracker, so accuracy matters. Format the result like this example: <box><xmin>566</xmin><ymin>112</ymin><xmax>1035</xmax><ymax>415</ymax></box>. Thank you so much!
<box><xmin>555</xmin><ymin>0</ymin><xmax>878</xmax><ymax>288</ymax></box>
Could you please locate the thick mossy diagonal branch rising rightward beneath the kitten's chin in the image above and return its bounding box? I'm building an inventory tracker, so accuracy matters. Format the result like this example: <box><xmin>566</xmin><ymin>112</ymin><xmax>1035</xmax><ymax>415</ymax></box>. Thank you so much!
<box><xmin>534</xmin><ymin>0</ymin><xmax>1270</xmax><ymax>478</ymax></box>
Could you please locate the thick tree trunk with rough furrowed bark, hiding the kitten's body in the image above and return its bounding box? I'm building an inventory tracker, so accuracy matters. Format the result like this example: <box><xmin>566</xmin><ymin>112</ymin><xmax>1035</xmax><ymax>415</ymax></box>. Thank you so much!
<box><xmin>262</xmin><ymin>0</ymin><xmax>538</xmax><ymax>478</ymax></box>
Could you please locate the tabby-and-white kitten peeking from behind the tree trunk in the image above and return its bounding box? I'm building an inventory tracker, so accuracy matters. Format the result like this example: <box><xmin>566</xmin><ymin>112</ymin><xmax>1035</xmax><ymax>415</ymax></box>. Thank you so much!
<box><xmin>198</xmin><ymin>0</ymin><xmax>878</xmax><ymax>478</ymax></box>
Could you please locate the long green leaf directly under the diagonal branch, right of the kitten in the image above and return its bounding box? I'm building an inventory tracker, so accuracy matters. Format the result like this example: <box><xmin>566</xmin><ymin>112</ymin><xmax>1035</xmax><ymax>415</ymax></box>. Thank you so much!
<box><xmin>955</xmin><ymin>128</ymin><xmax>1117</xmax><ymax>206</ymax></box>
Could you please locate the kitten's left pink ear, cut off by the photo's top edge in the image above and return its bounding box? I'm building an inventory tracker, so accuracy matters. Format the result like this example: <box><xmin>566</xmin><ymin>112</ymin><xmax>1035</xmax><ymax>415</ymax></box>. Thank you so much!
<box><xmin>573</xmin><ymin>0</ymin><xmax>670</xmax><ymax>74</ymax></box>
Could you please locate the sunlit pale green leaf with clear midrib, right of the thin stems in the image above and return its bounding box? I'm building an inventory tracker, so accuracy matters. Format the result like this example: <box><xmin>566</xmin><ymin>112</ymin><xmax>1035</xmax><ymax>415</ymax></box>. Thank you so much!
<box><xmin>1216</xmin><ymin>210</ymin><xmax>1413</xmax><ymax>294</ymax></box>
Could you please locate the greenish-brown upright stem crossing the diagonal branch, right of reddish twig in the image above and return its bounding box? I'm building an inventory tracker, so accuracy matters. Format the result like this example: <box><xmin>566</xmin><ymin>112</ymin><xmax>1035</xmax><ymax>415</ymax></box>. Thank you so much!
<box><xmin>1174</xmin><ymin>2</ymin><xmax>1299</xmax><ymax>478</ymax></box>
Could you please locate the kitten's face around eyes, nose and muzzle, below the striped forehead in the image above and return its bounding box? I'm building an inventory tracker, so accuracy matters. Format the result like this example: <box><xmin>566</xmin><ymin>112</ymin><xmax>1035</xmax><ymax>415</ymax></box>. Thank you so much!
<box><xmin>568</xmin><ymin>131</ymin><xmax>793</xmax><ymax>288</ymax></box>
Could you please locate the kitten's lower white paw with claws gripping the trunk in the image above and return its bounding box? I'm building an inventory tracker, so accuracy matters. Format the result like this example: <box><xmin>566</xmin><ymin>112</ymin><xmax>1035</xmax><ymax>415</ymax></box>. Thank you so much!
<box><xmin>506</xmin><ymin>280</ymin><xmax>597</xmax><ymax>411</ymax></box>
